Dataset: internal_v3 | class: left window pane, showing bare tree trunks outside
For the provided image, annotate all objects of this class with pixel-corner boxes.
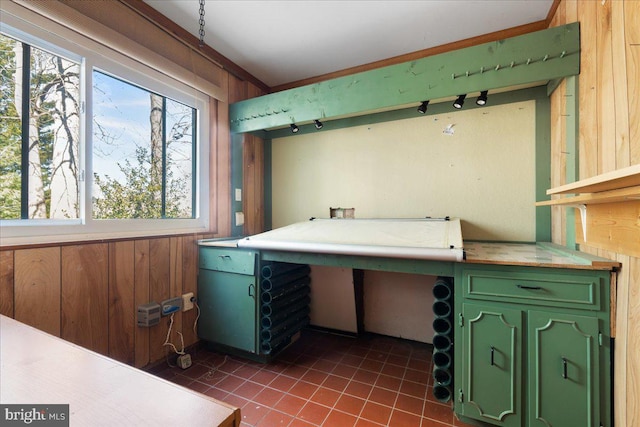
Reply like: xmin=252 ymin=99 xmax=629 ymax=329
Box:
xmin=0 ymin=36 xmax=80 ymax=219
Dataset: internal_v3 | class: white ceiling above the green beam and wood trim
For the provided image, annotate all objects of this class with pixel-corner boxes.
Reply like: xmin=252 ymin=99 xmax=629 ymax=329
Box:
xmin=144 ymin=0 xmax=553 ymax=87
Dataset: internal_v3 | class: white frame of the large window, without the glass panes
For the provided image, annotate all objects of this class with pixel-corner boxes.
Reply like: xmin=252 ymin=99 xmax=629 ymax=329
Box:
xmin=0 ymin=13 xmax=210 ymax=246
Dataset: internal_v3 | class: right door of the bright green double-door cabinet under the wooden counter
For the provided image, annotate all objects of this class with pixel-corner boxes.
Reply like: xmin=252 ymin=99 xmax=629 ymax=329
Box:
xmin=528 ymin=311 xmax=600 ymax=427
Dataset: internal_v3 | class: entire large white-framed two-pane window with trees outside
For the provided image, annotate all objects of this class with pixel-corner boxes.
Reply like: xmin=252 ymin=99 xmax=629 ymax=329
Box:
xmin=0 ymin=17 xmax=209 ymax=244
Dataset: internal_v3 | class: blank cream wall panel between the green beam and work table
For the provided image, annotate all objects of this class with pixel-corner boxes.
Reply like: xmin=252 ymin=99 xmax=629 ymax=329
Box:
xmin=272 ymin=100 xmax=536 ymax=241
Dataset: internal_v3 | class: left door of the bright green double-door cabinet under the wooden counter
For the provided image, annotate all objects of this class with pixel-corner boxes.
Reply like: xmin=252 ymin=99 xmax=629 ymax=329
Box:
xmin=460 ymin=304 xmax=523 ymax=427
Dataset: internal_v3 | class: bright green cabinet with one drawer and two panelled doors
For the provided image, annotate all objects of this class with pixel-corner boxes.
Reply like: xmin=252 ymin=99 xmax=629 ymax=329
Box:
xmin=454 ymin=265 xmax=611 ymax=427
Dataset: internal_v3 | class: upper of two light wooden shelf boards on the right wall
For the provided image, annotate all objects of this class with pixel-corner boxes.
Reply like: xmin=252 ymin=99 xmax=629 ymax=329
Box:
xmin=547 ymin=165 xmax=640 ymax=195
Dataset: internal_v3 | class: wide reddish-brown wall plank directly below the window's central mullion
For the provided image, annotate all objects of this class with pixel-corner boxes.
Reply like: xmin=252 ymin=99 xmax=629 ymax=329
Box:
xmin=60 ymin=243 xmax=109 ymax=354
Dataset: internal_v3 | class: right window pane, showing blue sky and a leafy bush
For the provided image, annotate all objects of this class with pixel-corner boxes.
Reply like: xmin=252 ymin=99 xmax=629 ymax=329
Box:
xmin=93 ymin=71 xmax=194 ymax=219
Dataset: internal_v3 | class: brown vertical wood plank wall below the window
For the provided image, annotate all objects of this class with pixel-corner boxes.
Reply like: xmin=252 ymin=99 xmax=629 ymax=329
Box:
xmin=0 ymin=234 xmax=214 ymax=367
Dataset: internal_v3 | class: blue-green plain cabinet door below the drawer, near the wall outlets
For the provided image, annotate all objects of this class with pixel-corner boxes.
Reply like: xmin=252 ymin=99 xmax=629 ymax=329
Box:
xmin=198 ymin=269 xmax=257 ymax=353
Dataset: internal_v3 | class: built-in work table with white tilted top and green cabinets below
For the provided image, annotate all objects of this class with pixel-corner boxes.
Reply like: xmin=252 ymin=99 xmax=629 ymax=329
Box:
xmin=198 ymin=226 xmax=620 ymax=427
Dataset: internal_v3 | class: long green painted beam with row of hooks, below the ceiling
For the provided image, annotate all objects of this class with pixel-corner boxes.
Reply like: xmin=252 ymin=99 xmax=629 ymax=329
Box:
xmin=229 ymin=23 xmax=580 ymax=133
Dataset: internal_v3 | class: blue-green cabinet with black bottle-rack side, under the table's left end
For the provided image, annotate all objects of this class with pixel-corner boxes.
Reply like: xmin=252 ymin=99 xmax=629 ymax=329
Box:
xmin=198 ymin=244 xmax=311 ymax=361
